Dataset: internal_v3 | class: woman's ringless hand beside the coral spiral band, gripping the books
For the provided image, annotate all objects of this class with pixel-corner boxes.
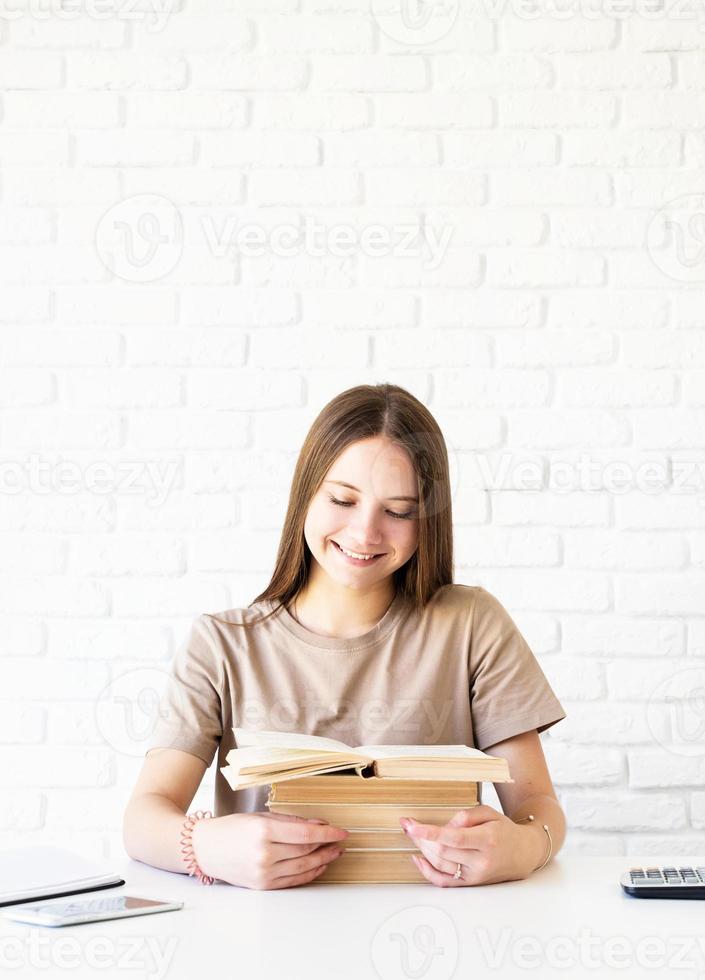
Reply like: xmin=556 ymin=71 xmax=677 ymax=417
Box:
xmin=191 ymin=813 xmax=348 ymax=889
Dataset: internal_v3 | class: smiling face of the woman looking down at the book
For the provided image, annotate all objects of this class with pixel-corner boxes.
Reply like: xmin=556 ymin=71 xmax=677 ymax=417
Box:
xmin=304 ymin=436 xmax=419 ymax=591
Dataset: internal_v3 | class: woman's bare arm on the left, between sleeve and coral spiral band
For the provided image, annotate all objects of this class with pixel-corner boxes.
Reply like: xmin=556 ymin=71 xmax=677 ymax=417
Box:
xmin=122 ymin=749 xmax=207 ymax=874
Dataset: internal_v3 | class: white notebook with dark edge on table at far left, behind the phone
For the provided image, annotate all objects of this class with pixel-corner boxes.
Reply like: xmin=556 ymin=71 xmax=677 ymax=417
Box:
xmin=0 ymin=844 xmax=125 ymax=905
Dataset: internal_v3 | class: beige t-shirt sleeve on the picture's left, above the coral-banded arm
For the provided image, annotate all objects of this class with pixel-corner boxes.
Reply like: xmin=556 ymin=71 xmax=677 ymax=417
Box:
xmin=147 ymin=616 xmax=224 ymax=766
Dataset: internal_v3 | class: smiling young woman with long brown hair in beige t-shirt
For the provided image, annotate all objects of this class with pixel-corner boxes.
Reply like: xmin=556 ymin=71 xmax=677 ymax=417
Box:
xmin=124 ymin=384 xmax=565 ymax=889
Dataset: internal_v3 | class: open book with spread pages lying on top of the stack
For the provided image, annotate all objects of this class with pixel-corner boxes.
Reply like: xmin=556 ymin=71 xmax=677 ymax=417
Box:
xmin=221 ymin=728 xmax=512 ymax=790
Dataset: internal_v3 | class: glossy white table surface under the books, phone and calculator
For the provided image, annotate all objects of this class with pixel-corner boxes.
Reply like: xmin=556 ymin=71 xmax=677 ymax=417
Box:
xmin=0 ymin=855 xmax=705 ymax=980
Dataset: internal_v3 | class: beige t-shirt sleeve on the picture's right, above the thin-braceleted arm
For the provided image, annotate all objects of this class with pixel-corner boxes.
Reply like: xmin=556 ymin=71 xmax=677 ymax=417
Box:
xmin=469 ymin=587 xmax=566 ymax=750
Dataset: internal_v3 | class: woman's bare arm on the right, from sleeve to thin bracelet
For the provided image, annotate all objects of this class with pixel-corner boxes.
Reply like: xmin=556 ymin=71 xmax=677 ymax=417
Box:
xmin=486 ymin=731 xmax=566 ymax=867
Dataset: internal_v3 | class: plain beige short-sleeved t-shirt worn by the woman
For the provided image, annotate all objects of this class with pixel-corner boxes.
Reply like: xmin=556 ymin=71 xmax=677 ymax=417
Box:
xmin=147 ymin=584 xmax=565 ymax=816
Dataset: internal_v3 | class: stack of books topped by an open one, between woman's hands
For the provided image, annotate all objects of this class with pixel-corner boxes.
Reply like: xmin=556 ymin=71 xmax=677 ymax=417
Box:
xmin=221 ymin=728 xmax=511 ymax=883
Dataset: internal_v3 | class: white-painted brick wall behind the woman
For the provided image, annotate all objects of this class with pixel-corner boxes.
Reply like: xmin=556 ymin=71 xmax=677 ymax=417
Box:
xmin=0 ymin=0 xmax=705 ymax=857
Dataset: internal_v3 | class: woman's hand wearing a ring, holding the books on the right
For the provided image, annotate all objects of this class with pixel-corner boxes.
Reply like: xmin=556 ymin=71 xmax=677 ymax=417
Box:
xmin=400 ymin=805 xmax=545 ymax=888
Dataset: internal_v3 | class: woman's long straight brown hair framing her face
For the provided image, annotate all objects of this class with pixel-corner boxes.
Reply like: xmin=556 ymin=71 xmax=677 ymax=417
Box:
xmin=206 ymin=384 xmax=453 ymax=626
